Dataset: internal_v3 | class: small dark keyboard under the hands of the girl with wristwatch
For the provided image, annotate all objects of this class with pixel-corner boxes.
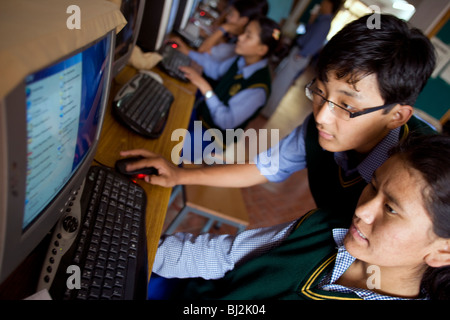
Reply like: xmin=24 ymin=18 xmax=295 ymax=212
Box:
xmin=159 ymin=43 xmax=192 ymax=82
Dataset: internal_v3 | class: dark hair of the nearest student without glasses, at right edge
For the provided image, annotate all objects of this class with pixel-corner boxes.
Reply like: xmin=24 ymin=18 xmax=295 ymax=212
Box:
xmin=391 ymin=135 xmax=450 ymax=300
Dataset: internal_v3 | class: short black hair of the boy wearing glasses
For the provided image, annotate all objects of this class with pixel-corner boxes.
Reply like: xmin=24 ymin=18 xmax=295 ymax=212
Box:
xmin=317 ymin=14 xmax=436 ymax=105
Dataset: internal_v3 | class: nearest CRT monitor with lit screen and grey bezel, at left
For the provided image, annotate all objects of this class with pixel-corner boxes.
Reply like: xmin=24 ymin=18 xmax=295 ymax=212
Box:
xmin=0 ymin=30 xmax=116 ymax=283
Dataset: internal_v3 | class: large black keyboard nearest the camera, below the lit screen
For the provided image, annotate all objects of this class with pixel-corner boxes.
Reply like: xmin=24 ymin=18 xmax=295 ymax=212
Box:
xmin=38 ymin=166 xmax=147 ymax=300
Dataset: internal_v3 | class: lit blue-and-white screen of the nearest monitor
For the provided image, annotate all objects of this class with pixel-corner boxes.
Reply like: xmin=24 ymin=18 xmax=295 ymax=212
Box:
xmin=22 ymin=38 xmax=107 ymax=229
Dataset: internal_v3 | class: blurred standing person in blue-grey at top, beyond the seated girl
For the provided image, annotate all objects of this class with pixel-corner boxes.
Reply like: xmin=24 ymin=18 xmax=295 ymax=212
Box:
xmin=262 ymin=0 xmax=342 ymax=118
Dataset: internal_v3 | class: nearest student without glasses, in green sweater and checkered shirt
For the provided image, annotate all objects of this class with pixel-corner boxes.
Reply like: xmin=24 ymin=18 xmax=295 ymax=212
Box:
xmin=149 ymin=135 xmax=450 ymax=300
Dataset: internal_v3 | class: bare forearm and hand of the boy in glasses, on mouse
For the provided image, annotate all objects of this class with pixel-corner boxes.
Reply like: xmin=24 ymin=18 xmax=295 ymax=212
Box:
xmin=120 ymin=149 xmax=268 ymax=188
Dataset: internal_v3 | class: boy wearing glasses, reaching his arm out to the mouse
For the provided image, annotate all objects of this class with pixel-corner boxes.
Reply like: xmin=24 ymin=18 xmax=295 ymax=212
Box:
xmin=121 ymin=15 xmax=435 ymax=215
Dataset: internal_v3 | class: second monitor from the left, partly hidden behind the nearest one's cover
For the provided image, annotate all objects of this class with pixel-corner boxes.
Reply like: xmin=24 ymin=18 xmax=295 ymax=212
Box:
xmin=112 ymin=0 xmax=145 ymax=77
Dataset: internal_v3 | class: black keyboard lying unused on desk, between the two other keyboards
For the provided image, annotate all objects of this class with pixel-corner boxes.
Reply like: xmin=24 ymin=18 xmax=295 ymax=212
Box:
xmin=113 ymin=73 xmax=174 ymax=139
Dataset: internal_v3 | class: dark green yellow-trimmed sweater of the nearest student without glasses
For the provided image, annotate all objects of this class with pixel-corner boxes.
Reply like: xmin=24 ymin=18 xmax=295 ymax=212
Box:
xmin=178 ymin=210 xmax=360 ymax=300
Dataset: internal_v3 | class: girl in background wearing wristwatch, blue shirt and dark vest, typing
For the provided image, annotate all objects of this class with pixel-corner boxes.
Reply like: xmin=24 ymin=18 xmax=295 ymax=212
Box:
xmin=174 ymin=16 xmax=280 ymax=160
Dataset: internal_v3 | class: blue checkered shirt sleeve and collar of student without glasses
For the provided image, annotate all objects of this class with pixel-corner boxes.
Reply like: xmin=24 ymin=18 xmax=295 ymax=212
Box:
xmin=153 ymin=221 xmax=428 ymax=300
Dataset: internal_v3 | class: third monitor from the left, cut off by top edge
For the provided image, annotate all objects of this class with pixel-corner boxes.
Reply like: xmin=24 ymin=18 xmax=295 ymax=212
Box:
xmin=137 ymin=0 xmax=180 ymax=52
